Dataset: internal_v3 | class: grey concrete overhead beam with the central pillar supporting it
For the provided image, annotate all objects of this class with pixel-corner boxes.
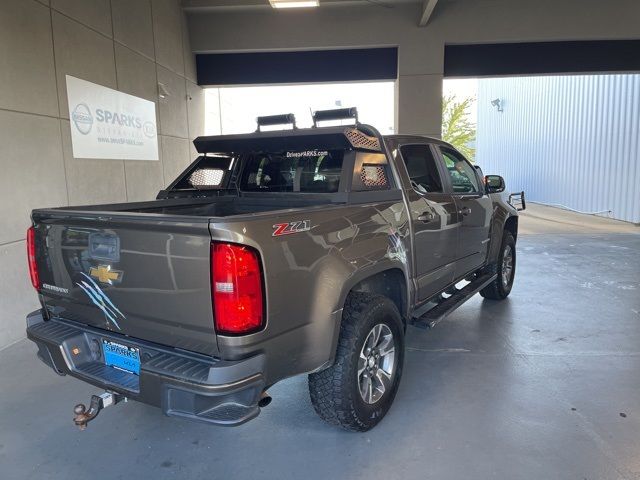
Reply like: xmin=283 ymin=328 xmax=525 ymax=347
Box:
xmin=189 ymin=0 xmax=640 ymax=136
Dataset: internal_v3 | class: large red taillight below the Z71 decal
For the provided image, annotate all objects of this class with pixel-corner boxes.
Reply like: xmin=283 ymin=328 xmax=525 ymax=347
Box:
xmin=211 ymin=242 xmax=264 ymax=335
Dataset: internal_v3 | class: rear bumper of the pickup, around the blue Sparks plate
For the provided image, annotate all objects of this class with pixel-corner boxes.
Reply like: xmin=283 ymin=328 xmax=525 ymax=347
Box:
xmin=27 ymin=311 xmax=265 ymax=426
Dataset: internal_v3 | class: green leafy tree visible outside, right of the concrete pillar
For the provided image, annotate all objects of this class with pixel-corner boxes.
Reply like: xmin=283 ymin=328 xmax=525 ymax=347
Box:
xmin=442 ymin=95 xmax=476 ymax=162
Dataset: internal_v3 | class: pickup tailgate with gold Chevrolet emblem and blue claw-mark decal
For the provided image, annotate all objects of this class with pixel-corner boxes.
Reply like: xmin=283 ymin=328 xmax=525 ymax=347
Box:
xmin=33 ymin=210 xmax=218 ymax=355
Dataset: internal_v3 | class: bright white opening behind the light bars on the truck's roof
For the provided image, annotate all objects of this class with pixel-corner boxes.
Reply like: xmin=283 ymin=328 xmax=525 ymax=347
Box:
xmin=205 ymin=81 xmax=395 ymax=135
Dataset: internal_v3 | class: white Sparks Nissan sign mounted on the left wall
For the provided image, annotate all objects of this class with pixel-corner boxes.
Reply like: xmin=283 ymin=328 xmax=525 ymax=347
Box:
xmin=67 ymin=75 xmax=158 ymax=160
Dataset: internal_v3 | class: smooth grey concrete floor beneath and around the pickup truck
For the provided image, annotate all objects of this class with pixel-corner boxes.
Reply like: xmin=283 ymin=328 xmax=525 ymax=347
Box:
xmin=0 ymin=215 xmax=640 ymax=480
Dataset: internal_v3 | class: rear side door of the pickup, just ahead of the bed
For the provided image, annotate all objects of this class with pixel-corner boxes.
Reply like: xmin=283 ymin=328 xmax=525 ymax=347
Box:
xmin=398 ymin=144 xmax=458 ymax=302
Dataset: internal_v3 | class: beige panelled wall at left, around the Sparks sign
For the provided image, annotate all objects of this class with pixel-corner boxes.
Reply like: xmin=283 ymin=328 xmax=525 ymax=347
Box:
xmin=0 ymin=0 xmax=204 ymax=348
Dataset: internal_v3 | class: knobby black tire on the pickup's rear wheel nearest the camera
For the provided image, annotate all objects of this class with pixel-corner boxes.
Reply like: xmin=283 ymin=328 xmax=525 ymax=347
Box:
xmin=309 ymin=292 xmax=404 ymax=432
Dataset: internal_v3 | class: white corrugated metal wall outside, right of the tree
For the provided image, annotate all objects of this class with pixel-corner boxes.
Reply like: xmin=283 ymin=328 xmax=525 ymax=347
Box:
xmin=476 ymin=74 xmax=640 ymax=223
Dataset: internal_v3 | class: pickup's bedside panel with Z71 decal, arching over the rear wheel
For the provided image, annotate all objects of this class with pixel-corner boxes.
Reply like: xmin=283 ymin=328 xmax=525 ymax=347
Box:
xmin=210 ymin=201 xmax=409 ymax=383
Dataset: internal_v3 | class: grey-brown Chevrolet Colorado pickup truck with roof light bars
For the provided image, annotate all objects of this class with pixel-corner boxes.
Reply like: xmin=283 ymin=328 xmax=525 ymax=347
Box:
xmin=27 ymin=109 xmax=518 ymax=431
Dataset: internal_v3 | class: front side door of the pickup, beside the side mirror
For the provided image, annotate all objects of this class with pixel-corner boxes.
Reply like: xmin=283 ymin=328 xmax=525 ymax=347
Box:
xmin=439 ymin=146 xmax=492 ymax=278
